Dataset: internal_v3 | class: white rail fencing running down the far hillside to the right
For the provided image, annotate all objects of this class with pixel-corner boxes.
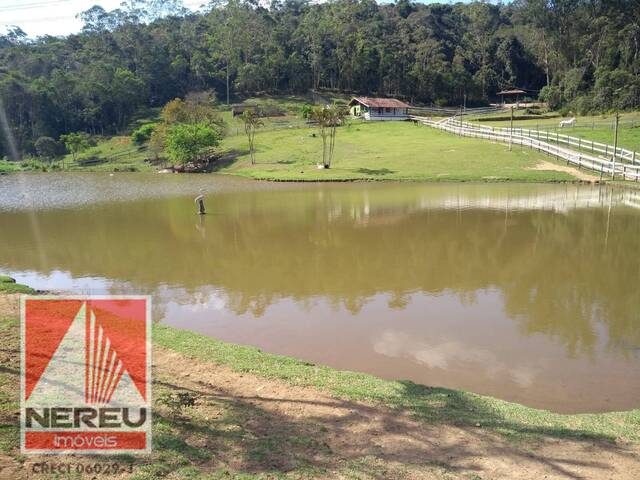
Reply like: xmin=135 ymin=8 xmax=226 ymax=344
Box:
xmin=411 ymin=116 xmax=640 ymax=181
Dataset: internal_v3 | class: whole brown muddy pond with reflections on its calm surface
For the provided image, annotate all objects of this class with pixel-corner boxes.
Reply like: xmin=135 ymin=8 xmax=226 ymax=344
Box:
xmin=0 ymin=174 xmax=640 ymax=412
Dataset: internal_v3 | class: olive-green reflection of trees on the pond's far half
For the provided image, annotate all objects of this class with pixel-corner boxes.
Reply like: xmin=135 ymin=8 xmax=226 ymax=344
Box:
xmin=0 ymin=184 xmax=640 ymax=410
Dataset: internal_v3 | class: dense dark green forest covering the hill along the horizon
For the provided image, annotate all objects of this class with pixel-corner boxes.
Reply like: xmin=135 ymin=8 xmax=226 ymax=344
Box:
xmin=0 ymin=0 xmax=640 ymax=158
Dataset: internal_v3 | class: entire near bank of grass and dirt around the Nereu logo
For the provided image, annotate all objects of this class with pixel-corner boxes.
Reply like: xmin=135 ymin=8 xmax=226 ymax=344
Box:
xmin=0 ymin=295 xmax=640 ymax=480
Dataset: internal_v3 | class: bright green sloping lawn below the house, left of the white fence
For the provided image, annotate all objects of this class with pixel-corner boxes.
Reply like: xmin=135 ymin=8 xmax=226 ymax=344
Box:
xmin=218 ymin=121 xmax=574 ymax=182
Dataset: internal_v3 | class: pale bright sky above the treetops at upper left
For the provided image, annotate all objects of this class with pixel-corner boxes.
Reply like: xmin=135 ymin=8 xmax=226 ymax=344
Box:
xmin=0 ymin=0 xmax=206 ymax=37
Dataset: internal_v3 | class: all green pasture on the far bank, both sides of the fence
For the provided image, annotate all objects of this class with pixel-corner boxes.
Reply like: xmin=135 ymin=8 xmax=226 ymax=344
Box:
xmin=6 ymin=99 xmax=640 ymax=182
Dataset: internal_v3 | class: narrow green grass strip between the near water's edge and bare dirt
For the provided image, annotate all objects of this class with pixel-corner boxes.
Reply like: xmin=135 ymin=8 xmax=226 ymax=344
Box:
xmin=154 ymin=325 xmax=640 ymax=441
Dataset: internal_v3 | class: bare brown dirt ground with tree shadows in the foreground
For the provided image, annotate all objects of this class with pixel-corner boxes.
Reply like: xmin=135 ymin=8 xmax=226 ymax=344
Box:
xmin=0 ymin=295 xmax=640 ymax=480
